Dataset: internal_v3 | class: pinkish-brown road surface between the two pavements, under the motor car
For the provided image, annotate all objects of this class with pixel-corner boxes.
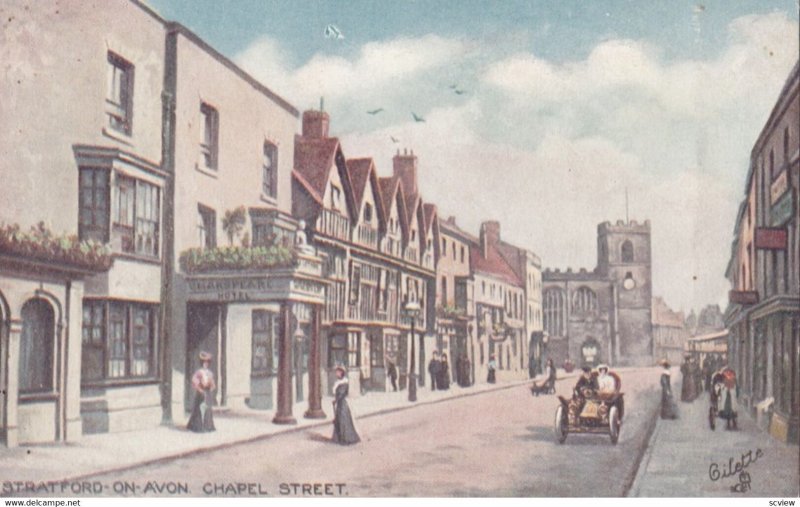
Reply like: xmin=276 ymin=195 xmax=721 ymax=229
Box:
xmin=88 ymin=369 xmax=659 ymax=497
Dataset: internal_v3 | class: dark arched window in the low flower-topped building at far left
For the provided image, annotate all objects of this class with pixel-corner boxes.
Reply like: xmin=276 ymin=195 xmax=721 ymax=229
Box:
xmin=19 ymin=299 xmax=55 ymax=394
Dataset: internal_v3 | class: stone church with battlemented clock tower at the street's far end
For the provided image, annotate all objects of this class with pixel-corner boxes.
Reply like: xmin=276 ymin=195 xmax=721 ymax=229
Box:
xmin=542 ymin=220 xmax=654 ymax=366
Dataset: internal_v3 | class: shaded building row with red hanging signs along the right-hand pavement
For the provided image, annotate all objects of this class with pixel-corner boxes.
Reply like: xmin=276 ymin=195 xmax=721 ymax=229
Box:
xmin=725 ymin=62 xmax=800 ymax=443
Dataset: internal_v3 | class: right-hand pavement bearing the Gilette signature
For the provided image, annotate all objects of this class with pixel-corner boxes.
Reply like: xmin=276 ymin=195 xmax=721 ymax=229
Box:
xmin=628 ymin=390 xmax=800 ymax=498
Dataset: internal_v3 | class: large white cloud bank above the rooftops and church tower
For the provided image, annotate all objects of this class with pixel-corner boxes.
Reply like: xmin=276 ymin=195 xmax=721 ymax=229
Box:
xmin=236 ymin=14 xmax=798 ymax=310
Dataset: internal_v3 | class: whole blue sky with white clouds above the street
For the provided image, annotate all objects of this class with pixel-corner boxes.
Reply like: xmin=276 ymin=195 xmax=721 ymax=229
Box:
xmin=148 ymin=0 xmax=800 ymax=312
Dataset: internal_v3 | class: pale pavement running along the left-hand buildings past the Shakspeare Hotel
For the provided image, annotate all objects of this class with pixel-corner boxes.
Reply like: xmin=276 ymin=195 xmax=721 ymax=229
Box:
xmin=0 ymin=372 xmax=570 ymax=482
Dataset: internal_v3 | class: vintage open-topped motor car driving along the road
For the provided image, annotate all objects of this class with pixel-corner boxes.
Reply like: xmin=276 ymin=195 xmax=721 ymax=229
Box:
xmin=554 ymin=372 xmax=625 ymax=444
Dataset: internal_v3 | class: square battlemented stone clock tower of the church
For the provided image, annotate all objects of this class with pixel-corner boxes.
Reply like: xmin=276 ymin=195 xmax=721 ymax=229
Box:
xmin=596 ymin=220 xmax=654 ymax=365
